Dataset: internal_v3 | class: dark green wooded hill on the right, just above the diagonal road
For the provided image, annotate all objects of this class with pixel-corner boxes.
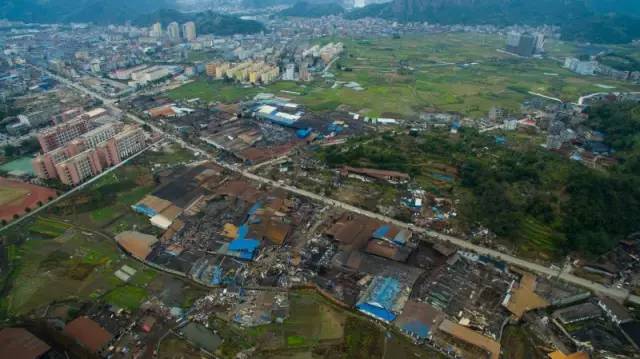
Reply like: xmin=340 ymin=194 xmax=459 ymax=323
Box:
xmin=318 ymin=102 xmax=640 ymax=258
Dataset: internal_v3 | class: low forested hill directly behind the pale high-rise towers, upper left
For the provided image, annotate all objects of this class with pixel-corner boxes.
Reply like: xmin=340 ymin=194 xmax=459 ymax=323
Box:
xmin=133 ymin=10 xmax=265 ymax=36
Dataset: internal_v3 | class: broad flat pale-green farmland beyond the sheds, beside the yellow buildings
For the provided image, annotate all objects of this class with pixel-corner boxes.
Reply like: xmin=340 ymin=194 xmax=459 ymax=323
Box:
xmin=169 ymin=33 xmax=640 ymax=117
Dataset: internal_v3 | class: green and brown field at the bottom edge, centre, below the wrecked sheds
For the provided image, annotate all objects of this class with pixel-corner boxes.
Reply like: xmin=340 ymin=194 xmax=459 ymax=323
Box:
xmin=211 ymin=290 xmax=442 ymax=359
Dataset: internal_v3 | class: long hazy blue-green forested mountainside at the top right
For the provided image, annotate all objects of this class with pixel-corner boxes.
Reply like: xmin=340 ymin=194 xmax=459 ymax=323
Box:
xmin=348 ymin=0 xmax=640 ymax=43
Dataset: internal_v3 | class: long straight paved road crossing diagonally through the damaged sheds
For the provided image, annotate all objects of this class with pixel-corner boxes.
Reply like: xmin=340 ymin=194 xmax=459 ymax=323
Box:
xmin=30 ymin=64 xmax=640 ymax=304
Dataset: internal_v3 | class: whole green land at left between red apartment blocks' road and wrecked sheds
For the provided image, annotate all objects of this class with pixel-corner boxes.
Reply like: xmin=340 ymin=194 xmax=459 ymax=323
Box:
xmin=0 ymin=146 xmax=199 ymax=317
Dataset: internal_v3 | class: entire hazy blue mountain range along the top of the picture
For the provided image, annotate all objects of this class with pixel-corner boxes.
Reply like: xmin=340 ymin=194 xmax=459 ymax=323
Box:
xmin=5 ymin=0 xmax=640 ymax=43
